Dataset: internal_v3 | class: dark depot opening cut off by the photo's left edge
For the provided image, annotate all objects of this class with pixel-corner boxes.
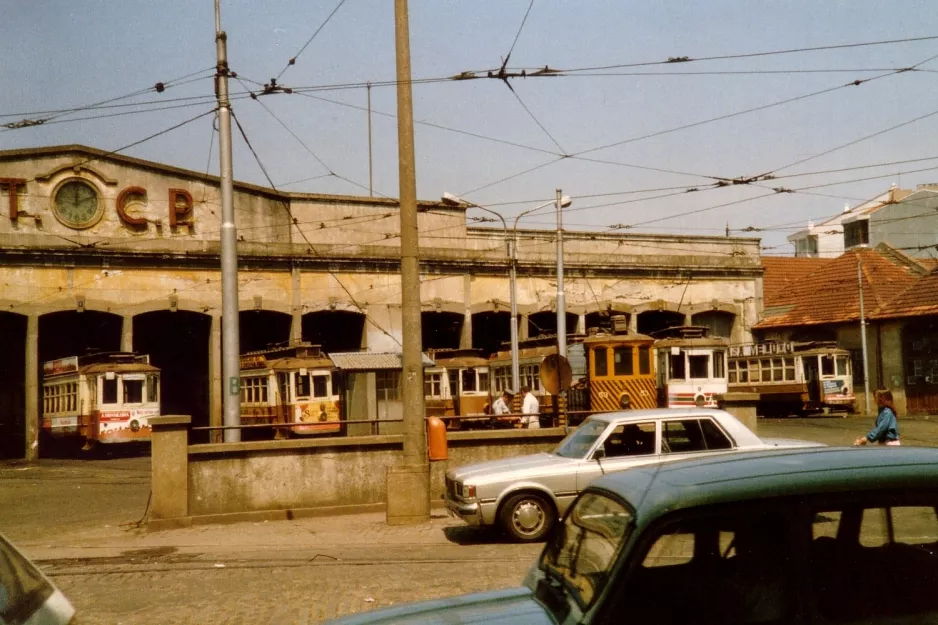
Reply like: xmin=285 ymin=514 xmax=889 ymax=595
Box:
xmin=0 ymin=312 xmax=26 ymax=459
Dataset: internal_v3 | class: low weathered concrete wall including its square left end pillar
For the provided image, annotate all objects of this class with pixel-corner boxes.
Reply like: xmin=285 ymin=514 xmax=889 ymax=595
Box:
xmin=150 ymin=421 xmax=565 ymax=529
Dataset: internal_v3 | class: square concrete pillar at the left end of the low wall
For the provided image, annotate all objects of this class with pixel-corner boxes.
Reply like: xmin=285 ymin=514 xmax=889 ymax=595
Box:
xmin=149 ymin=415 xmax=192 ymax=529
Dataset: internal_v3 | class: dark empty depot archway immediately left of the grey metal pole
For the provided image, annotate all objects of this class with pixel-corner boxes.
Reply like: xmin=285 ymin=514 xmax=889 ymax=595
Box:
xmin=134 ymin=310 xmax=210 ymax=442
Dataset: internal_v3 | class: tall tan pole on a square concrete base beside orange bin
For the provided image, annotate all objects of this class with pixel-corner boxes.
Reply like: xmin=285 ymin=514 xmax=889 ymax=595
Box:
xmin=387 ymin=0 xmax=430 ymax=525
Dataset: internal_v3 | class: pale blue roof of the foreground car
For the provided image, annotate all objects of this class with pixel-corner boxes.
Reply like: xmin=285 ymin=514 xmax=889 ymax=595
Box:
xmin=591 ymin=447 xmax=938 ymax=525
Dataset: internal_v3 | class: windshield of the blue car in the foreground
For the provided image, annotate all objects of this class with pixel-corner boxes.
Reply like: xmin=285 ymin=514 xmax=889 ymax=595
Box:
xmin=539 ymin=492 xmax=632 ymax=611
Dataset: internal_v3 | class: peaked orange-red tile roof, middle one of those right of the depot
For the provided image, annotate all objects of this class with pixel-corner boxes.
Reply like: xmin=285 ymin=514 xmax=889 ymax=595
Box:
xmin=755 ymin=249 xmax=921 ymax=329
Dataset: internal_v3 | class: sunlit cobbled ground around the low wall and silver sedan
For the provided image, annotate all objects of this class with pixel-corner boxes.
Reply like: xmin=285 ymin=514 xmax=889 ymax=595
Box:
xmin=0 ymin=417 xmax=938 ymax=625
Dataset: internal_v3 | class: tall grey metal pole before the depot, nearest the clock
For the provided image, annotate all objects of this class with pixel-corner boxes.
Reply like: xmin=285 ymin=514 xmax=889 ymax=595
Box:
xmin=215 ymin=0 xmax=241 ymax=443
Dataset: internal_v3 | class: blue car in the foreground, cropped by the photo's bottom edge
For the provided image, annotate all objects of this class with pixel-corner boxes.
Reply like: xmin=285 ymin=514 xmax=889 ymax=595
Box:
xmin=335 ymin=447 xmax=938 ymax=625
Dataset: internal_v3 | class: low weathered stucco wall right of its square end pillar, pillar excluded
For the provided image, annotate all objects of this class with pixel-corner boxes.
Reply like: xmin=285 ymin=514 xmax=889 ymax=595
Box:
xmin=187 ymin=429 xmax=564 ymax=516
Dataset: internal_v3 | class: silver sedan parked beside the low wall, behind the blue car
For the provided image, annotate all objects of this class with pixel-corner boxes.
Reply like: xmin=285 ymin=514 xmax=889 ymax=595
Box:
xmin=444 ymin=408 xmax=820 ymax=541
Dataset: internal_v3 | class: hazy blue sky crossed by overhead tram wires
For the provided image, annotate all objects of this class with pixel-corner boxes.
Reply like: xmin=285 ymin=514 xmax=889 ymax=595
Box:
xmin=0 ymin=0 xmax=938 ymax=253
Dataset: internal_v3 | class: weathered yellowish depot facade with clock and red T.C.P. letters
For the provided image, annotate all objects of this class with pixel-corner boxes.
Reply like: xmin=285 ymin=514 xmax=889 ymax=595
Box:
xmin=0 ymin=145 xmax=938 ymax=458
